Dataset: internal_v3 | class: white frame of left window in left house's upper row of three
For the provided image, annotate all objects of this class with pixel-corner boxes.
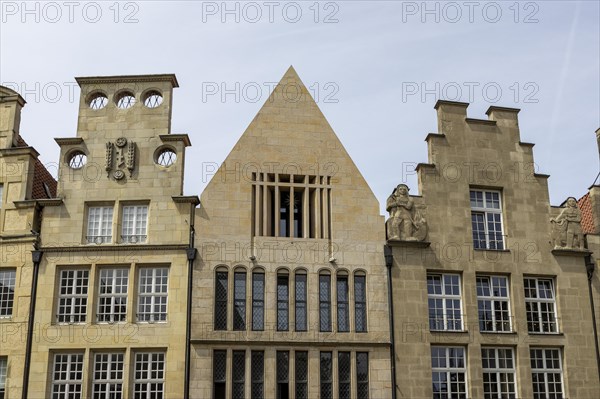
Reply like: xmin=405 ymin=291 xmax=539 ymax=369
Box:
xmin=56 ymin=269 xmax=90 ymax=324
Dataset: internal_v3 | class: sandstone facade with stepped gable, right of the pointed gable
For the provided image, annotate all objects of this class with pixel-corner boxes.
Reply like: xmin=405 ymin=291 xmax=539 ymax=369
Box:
xmin=389 ymin=101 xmax=600 ymax=399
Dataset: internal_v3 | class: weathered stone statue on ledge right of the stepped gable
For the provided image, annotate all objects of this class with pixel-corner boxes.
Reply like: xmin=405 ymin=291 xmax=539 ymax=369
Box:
xmin=550 ymin=197 xmax=584 ymax=249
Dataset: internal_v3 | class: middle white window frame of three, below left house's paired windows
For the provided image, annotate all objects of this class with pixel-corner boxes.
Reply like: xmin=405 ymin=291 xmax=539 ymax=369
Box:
xmin=96 ymin=267 xmax=129 ymax=323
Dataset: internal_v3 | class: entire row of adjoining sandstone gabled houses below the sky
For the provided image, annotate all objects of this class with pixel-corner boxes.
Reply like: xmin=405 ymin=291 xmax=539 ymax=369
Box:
xmin=0 ymin=68 xmax=600 ymax=399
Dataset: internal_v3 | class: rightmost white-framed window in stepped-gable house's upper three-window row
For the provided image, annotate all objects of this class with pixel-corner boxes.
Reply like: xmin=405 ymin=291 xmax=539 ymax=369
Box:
xmin=524 ymin=278 xmax=558 ymax=334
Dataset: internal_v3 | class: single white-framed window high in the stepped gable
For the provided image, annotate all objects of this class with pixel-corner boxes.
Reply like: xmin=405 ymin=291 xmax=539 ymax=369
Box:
xmin=470 ymin=190 xmax=504 ymax=250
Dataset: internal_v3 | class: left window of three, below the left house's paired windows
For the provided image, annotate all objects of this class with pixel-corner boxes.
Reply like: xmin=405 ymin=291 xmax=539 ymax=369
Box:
xmin=56 ymin=270 xmax=90 ymax=323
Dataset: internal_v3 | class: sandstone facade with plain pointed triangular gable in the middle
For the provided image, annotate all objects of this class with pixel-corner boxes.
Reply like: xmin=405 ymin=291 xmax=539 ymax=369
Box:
xmin=190 ymin=68 xmax=391 ymax=398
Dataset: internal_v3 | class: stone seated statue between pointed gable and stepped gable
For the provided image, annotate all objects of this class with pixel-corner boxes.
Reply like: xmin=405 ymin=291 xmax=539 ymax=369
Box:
xmin=385 ymin=184 xmax=427 ymax=241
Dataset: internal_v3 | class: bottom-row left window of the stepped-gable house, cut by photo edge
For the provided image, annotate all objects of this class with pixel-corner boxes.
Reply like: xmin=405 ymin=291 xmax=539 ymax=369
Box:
xmin=431 ymin=346 xmax=467 ymax=399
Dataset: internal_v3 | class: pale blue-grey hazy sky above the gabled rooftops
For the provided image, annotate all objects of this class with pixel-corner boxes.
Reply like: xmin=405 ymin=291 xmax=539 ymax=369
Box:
xmin=0 ymin=1 xmax=600 ymax=212
